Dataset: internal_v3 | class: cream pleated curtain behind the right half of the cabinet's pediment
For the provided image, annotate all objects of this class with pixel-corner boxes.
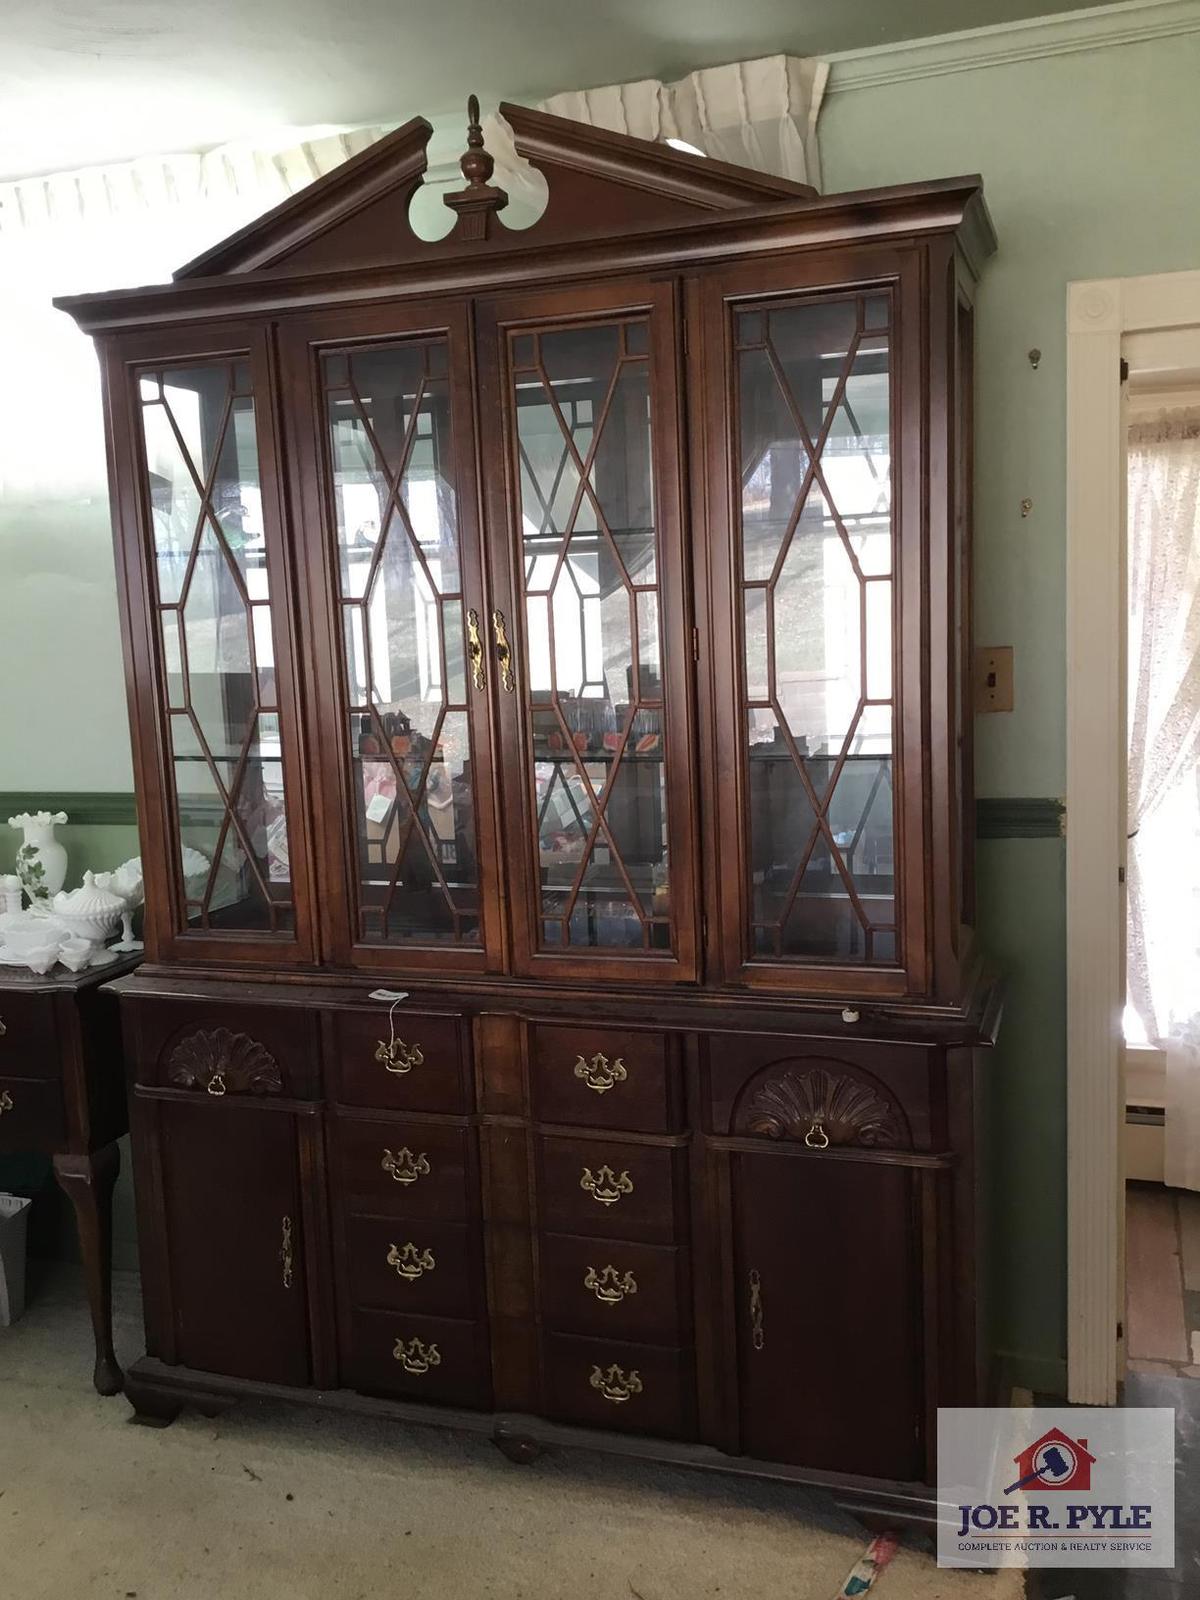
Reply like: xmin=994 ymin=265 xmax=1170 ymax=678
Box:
xmin=485 ymin=56 xmax=829 ymax=226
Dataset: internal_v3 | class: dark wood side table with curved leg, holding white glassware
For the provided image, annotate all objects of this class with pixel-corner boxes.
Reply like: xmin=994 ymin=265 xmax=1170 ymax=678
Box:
xmin=0 ymin=957 xmax=138 ymax=1395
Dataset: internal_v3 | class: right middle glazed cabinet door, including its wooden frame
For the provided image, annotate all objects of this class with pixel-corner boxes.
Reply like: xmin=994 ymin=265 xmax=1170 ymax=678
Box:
xmin=478 ymin=283 xmax=698 ymax=981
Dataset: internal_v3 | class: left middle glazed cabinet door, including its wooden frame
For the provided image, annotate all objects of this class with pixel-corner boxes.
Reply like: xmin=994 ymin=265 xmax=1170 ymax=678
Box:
xmin=282 ymin=306 xmax=502 ymax=971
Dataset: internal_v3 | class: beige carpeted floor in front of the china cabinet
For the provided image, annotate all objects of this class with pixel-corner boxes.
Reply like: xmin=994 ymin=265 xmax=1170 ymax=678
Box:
xmin=0 ymin=1274 xmax=1022 ymax=1600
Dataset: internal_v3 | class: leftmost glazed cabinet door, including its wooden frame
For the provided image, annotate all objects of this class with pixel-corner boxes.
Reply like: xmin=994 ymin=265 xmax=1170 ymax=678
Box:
xmin=106 ymin=325 xmax=314 ymax=966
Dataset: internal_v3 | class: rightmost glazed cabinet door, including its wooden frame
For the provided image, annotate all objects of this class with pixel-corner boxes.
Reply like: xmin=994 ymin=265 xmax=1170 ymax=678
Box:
xmin=693 ymin=251 xmax=939 ymax=995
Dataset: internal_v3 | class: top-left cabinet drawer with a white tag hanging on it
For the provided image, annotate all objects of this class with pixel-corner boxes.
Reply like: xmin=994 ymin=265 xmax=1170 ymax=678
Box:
xmin=333 ymin=1003 xmax=474 ymax=1115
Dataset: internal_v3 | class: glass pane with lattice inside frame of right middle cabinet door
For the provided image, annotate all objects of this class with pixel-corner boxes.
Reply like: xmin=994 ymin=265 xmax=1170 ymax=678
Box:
xmin=512 ymin=318 xmax=670 ymax=950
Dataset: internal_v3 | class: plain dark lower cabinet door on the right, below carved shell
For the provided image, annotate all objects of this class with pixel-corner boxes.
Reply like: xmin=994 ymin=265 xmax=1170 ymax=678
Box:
xmin=731 ymin=1155 xmax=922 ymax=1480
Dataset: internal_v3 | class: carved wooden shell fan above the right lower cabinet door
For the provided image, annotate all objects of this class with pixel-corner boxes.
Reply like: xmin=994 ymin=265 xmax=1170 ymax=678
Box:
xmin=734 ymin=1067 xmax=910 ymax=1149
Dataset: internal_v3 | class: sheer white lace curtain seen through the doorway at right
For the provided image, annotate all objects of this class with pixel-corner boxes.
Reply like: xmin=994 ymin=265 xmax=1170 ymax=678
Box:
xmin=1128 ymin=411 xmax=1200 ymax=1189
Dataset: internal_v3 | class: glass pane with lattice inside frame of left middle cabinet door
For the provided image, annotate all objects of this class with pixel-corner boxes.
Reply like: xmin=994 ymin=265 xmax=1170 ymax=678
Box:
xmin=323 ymin=341 xmax=480 ymax=944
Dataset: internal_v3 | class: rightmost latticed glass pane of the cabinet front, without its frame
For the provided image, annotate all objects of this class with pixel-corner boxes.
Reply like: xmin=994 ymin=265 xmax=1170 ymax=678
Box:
xmin=734 ymin=293 xmax=901 ymax=965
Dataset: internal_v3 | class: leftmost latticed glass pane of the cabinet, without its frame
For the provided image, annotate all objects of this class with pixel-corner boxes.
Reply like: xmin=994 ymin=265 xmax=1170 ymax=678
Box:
xmin=138 ymin=362 xmax=293 ymax=934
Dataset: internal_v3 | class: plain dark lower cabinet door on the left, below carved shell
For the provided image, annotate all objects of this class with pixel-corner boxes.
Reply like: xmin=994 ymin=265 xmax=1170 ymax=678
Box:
xmin=160 ymin=1102 xmax=310 ymax=1386
